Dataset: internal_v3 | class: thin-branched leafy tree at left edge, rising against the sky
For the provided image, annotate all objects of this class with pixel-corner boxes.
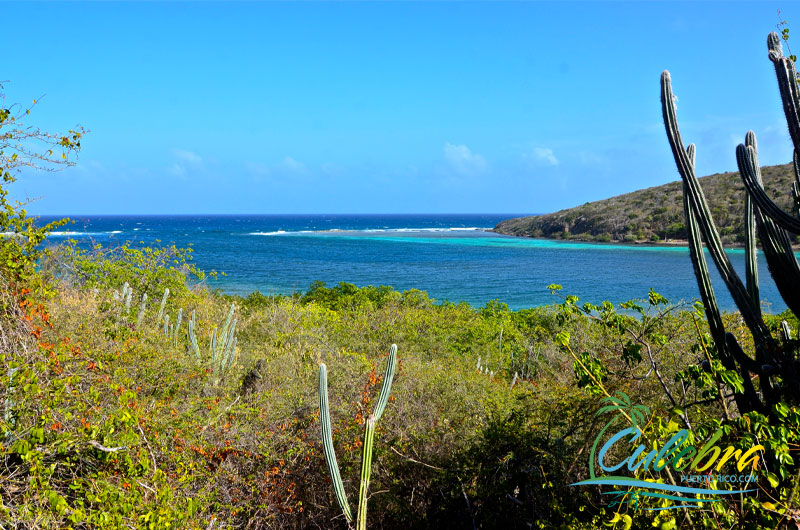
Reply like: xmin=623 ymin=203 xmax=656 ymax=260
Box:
xmin=0 ymin=83 xmax=86 ymax=288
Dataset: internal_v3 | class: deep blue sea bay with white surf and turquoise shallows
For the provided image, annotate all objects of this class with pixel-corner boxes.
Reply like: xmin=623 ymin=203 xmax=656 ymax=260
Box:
xmin=36 ymin=214 xmax=785 ymax=313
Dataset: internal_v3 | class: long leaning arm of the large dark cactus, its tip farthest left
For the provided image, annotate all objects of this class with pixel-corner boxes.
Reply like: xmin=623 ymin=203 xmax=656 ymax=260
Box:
xmin=661 ymin=70 xmax=772 ymax=344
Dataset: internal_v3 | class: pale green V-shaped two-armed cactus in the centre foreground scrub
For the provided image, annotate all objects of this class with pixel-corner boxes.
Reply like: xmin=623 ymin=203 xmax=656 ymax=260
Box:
xmin=319 ymin=344 xmax=397 ymax=530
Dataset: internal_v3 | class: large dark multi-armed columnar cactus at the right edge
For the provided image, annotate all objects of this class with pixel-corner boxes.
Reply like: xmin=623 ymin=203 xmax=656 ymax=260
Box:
xmin=661 ymin=32 xmax=800 ymax=414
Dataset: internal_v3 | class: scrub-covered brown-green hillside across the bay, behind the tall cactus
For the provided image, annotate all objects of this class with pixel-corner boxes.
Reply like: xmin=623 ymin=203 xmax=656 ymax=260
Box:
xmin=494 ymin=164 xmax=794 ymax=245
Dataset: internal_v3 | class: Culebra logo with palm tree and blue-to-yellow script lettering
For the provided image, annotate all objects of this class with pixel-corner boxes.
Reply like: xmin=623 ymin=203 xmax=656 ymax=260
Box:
xmin=572 ymin=392 xmax=764 ymax=510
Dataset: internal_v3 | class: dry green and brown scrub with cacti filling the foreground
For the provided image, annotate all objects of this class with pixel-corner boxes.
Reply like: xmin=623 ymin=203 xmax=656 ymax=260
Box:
xmin=0 ymin=27 xmax=800 ymax=530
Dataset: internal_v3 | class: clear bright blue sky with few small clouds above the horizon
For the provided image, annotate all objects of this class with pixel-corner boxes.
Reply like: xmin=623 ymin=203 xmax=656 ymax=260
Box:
xmin=6 ymin=1 xmax=800 ymax=214
